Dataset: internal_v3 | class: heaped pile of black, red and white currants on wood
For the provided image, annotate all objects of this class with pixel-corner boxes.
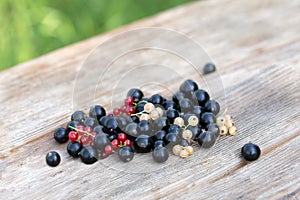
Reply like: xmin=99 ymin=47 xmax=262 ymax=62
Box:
xmin=47 ymin=80 xmax=236 ymax=166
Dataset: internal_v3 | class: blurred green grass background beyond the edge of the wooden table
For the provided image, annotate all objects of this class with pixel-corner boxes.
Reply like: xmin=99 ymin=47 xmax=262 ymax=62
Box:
xmin=0 ymin=0 xmax=192 ymax=70
